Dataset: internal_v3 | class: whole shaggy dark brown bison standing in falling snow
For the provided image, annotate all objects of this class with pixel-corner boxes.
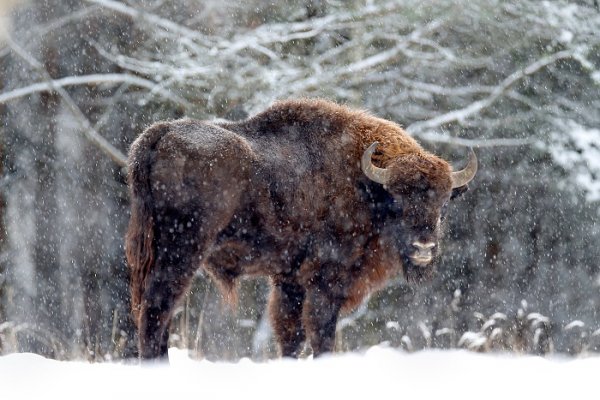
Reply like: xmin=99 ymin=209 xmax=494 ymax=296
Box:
xmin=126 ymin=100 xmax=477 ymax=359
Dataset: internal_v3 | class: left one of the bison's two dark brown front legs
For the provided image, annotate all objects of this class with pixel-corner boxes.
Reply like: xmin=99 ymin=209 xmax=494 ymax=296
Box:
xmin=269 ymin=279 xmax=305 ymax=358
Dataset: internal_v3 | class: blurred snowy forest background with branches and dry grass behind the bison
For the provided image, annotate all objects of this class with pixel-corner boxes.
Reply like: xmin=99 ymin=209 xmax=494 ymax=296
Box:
xmin=0 ymin=0 xmax=600 ymax=360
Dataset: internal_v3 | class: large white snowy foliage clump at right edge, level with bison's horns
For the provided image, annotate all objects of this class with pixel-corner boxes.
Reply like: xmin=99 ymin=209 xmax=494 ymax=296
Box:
xmin=549 ymin=121 xmax=600 ymax=202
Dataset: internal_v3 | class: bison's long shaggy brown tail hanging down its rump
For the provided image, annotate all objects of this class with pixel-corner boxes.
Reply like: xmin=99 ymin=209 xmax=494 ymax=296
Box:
xmin=125 ymin=123 xmax=169 ymax=326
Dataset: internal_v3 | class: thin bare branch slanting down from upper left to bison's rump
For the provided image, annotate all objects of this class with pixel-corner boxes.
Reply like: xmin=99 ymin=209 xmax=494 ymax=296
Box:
xmin=6 ymin=36 xmax=127 ymax=169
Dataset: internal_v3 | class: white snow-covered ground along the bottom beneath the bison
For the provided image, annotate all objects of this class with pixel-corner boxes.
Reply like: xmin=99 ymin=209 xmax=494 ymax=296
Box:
xmin=0 ymin=347 xmax=600 ymax=400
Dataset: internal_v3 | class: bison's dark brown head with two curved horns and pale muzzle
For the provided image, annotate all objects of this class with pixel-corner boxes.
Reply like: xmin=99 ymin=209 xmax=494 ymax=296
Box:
xmin=361 ymin=142 xmax=477 ymax=281
